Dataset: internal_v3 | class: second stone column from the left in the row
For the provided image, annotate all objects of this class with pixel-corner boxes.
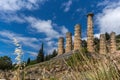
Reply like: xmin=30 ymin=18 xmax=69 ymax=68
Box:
xmin=65 ymin=32 xmax=72 ymax=53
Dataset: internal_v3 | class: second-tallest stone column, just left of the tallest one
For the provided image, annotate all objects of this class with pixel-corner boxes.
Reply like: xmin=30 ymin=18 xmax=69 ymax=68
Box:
xmin=74 ymin=24 xmax=82 ymax=50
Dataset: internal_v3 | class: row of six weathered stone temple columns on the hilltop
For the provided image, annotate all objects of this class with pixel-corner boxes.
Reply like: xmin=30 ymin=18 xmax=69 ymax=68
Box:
xmin=58 ymin=13 xmax=116 ymax=55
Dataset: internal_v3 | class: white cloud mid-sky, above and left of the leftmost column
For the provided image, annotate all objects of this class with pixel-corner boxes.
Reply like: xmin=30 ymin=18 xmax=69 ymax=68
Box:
xmin=24 ymin=16 xmax=68 ymax=39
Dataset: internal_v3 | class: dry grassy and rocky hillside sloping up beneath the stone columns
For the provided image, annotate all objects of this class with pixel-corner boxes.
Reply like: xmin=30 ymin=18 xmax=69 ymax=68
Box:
xmin=23 ymin=51 xmax=120 ymax=80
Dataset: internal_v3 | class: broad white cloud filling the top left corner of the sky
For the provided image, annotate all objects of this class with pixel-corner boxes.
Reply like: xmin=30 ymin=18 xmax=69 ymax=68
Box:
xmin=0 ymin=0 xmax=48 ymax=23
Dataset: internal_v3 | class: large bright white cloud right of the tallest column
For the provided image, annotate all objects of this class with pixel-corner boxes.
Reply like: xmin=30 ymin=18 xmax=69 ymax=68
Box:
xmin=95 ymin=1 xmax=120 ymax=34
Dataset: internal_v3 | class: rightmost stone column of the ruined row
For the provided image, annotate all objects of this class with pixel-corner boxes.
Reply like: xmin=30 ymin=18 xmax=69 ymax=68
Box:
xmin=110 ymin=32 xmax=117 ymax=53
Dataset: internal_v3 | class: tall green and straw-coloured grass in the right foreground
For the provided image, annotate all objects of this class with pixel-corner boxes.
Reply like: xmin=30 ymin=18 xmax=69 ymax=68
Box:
xmin=65 ymin=52 xmax=120 ymax=80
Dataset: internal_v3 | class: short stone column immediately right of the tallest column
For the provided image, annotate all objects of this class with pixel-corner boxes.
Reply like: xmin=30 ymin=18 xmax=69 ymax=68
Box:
xmin=99 ymin=34 xmax=107 ymax=54
